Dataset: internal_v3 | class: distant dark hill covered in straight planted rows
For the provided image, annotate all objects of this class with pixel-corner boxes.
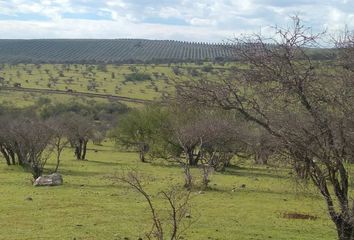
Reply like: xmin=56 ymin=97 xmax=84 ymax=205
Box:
xmin=0 ymin=39 xmax=238 ymax=63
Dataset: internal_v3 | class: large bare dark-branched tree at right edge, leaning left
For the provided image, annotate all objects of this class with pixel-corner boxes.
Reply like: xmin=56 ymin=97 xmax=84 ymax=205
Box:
xmin=177 ymin=16 xmax=354 ymax=240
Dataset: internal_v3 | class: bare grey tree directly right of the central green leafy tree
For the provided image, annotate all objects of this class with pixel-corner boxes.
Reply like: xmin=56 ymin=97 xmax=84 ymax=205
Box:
xmin=156 ymin=108 xmax=241 ymax=188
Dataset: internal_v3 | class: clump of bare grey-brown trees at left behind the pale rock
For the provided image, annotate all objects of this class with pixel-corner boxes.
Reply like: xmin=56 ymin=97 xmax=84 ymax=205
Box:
xmin=0 ymin=113 xmax=97 ymax=179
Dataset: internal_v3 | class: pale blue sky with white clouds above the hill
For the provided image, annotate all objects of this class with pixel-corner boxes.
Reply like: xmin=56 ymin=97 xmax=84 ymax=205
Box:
xmin=0 ymin=0 xmax=354 ymax=42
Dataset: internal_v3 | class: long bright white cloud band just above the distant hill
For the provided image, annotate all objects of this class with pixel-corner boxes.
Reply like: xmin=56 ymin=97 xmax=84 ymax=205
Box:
xmin=0 ymin=19 xmax=233 ymax=42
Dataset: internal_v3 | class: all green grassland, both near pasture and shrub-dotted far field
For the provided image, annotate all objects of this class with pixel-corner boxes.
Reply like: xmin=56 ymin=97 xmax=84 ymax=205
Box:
xmin=0 ymin=63 xmax=336 ymax=240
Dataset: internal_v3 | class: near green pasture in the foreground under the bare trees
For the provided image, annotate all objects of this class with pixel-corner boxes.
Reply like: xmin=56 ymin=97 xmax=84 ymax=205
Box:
xmin=0 ymin=142 xmax=335 ymax=240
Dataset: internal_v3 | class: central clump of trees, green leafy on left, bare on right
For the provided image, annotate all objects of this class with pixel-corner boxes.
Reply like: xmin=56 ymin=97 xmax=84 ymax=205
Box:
xmin=111 ymin=104 xmax=276 ymax=188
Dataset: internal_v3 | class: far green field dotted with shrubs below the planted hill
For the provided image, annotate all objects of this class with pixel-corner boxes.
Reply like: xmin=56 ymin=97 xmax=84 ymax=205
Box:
xmin=0 ymin=63 xmax=234 ymax=106
